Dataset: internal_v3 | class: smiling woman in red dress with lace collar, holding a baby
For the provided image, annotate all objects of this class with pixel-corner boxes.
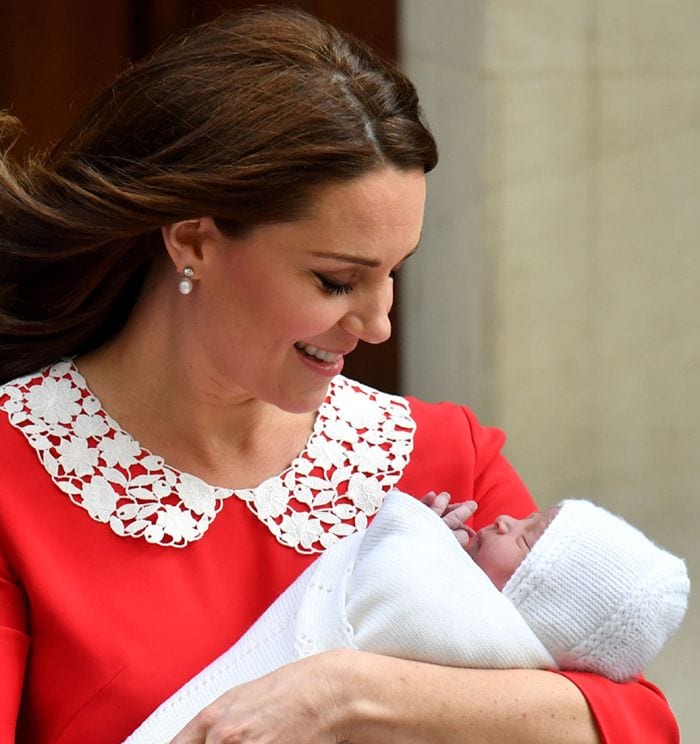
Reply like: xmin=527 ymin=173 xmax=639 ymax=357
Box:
xmin=0 ymin=10 xmax=677 ymax=744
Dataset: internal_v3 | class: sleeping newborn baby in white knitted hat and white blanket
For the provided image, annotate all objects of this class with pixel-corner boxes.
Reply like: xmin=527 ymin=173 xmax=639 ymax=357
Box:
xmin=127 ymin=491 xmax=689 ymax=744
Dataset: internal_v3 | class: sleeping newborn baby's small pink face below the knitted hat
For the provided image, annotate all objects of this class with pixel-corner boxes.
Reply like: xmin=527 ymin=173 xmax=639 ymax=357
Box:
xmin=466 ymin=507 xmax=557 ymax=590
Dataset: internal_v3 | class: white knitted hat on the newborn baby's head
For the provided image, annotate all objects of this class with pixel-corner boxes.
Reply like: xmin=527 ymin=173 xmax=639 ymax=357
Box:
xmin=503 ymin=499 xmax=690 ymax=681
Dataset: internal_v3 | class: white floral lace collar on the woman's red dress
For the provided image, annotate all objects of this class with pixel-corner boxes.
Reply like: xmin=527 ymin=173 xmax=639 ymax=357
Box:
xmin=0 ymin=361 xmax=415 ymax=553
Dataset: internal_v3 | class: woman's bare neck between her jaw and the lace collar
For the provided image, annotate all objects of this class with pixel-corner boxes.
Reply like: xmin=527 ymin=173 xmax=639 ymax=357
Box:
xmin=76 ymin=290 xmax=315 ymax=488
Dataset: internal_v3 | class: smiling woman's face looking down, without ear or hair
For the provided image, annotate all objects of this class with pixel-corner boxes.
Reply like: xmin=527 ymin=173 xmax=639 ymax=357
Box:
xmin=183 ymin=168 xmax=425 ymax=412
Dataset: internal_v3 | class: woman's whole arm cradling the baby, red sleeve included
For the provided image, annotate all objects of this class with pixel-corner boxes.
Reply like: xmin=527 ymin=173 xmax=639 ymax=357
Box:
xmin=174 ymin=407 xmax=678 ymax=744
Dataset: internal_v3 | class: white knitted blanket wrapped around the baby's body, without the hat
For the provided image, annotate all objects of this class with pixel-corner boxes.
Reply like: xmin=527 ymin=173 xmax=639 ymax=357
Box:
xmin=126 ymin=491 xmax=556 ymax=744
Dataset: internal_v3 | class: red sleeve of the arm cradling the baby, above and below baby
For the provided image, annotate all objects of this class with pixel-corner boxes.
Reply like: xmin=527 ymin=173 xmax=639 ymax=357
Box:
xmin=398 ymin=399 xmax=680 ymax=744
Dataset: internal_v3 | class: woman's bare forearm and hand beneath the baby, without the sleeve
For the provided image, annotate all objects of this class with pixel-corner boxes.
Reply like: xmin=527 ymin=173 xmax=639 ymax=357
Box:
xmin=173 ymin=650 xmax=599 ymax=744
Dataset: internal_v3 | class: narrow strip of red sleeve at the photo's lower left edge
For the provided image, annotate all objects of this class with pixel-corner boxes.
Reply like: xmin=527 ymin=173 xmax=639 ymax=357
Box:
xmin=0 ymin=557 xmax=29 ymax=744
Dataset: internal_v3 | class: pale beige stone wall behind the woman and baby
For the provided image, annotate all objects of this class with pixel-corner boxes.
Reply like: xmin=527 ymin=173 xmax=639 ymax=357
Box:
xmin=400 ymin=0 xmax=700 ymax=741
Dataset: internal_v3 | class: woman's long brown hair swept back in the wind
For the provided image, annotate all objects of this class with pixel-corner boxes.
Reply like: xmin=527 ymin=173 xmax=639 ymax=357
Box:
xmin=0 ymin=8 xmax=437 ymax=382
